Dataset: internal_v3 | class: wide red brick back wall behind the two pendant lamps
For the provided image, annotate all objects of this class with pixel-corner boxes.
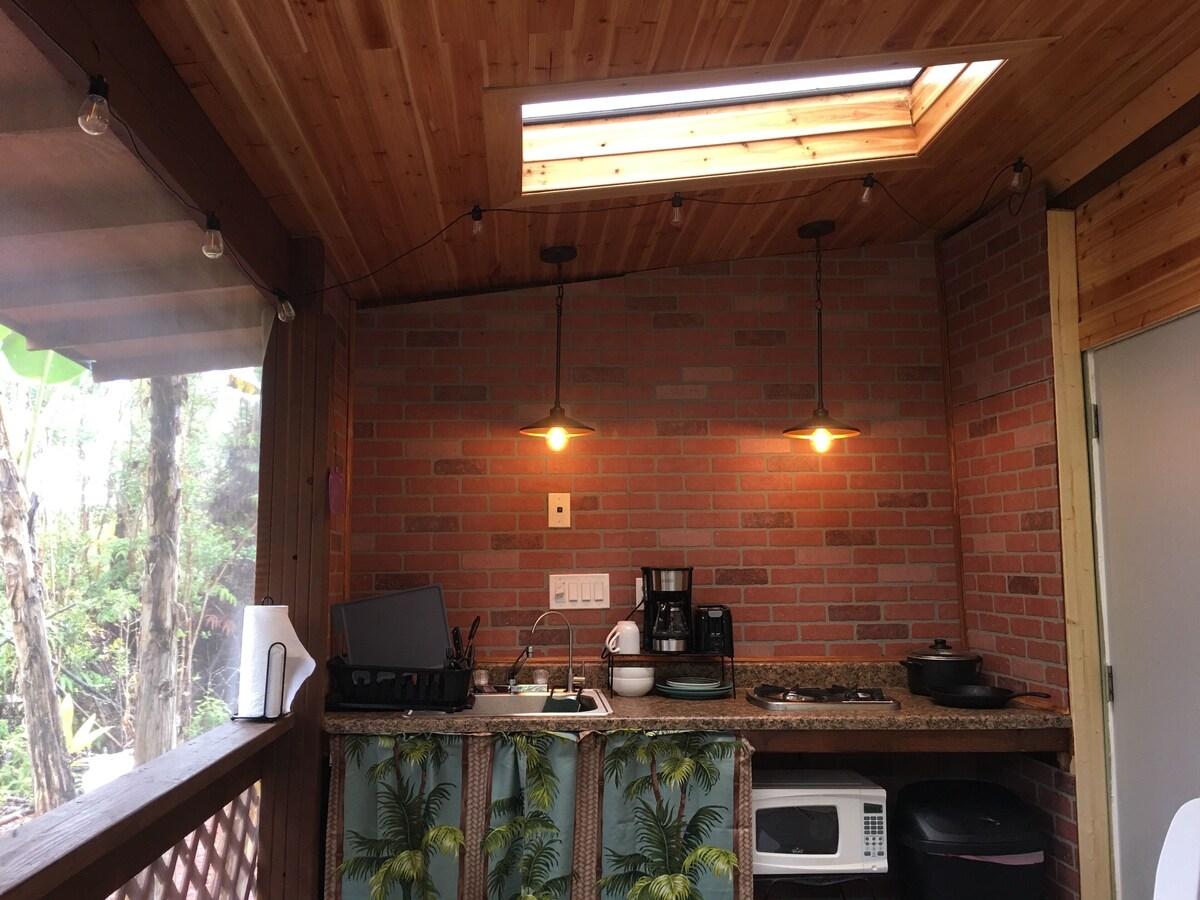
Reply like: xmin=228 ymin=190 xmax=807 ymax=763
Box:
xmin=350 ymin=244 xmax=959 ymax=659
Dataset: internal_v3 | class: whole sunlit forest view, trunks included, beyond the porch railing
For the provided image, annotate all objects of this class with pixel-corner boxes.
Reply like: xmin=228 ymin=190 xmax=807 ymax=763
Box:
xmin=0 ymin=335 xmax=260 ymax=828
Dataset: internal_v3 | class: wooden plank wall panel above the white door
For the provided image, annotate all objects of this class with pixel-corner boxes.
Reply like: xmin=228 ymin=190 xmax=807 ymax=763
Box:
xmin=1075 ymin=130 xmax=1200 ymax=349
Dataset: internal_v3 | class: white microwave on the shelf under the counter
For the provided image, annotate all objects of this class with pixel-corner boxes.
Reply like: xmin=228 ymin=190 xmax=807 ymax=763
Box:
xmin=754 ymin=769 xmax=888 ymax=875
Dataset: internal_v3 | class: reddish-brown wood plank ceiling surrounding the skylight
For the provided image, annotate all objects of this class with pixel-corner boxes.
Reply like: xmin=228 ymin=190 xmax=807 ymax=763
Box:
xmin=11 ymin=0 xmax=1200 ymax=336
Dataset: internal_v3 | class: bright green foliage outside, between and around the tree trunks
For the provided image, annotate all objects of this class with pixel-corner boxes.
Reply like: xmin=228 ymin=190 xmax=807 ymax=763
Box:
xmin=0 ymin=367 xmax=259 ymax=797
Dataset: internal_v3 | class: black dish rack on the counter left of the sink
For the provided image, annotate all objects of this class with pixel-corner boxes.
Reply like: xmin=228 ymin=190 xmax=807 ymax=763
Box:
xmin=325 ymin=656 xmax=472 ymax=713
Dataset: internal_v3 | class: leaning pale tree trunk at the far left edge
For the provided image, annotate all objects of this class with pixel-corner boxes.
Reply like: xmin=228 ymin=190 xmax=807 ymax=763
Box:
xmin=0 ymin=400 xmax=74 ymax=814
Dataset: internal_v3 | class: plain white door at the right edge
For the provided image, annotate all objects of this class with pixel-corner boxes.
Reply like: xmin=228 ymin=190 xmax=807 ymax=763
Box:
xmin=1091 ymin=314 xmax=1200 ymax=900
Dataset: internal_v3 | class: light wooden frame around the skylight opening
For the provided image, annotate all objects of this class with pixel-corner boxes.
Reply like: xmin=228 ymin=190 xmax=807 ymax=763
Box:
xmin=484 ymin=37 xmax=1055 ymax=205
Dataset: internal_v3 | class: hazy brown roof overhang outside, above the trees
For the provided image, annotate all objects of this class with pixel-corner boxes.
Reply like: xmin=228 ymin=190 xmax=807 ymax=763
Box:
xmin=0 ymin=2 xmax=271 ymax=380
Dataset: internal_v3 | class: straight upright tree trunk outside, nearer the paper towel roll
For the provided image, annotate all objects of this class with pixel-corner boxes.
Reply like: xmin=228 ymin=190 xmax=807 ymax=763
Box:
xmin=133 ymin=376 xmax=187 ymax=764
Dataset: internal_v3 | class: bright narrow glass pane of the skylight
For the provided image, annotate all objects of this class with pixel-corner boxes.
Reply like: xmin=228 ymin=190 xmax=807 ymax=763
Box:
xmin=521 ymin=66 xmax=922 ymax=124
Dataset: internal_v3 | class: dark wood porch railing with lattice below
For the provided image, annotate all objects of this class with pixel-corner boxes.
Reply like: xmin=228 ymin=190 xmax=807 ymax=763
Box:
xmin=0 ymin=718 xmax=293 ymax=900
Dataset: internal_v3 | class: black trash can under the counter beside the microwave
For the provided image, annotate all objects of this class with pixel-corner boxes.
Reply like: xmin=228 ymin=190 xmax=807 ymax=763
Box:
xmin=892 ymin=780 xmax=1046 ymax=900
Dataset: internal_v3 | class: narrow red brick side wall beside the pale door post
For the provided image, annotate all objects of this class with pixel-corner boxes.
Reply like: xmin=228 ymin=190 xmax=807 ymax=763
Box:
xmin=943 ymin=188 xmax=1067 ymax=704
